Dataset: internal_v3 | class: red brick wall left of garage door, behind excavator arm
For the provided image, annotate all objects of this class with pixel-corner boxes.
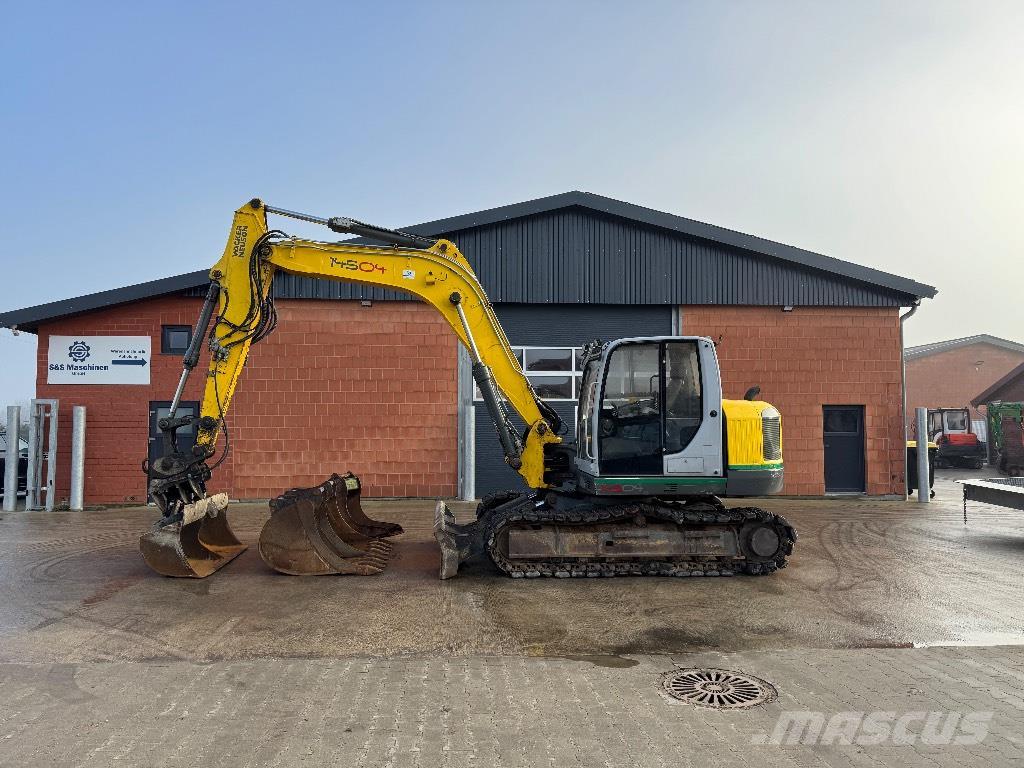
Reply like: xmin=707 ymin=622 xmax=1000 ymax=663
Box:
xmin=36 ymin=297 xmax=458 ymax=504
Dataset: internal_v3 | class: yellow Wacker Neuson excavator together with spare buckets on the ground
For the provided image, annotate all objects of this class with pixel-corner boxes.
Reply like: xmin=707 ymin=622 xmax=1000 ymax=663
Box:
xmin=141 ymin=200 xmax=797 ymax=579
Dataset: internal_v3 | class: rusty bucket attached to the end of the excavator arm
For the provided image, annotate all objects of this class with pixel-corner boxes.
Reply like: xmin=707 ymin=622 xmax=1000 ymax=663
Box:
xmin=139 ymin=494 xmax=246 ymax=579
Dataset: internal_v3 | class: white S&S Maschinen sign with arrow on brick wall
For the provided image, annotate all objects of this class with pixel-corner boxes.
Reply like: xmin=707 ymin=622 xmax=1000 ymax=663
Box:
xmin=46 ymin=336 xmax=152 ymax=384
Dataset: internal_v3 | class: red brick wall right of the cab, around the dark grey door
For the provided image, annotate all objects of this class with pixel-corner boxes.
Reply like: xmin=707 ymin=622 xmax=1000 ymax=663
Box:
xmin=681 ymin=306 xmax=905 ymax=495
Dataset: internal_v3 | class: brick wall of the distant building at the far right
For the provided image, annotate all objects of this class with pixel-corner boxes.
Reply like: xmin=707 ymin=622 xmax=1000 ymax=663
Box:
xmin=906 ymin=344 xmax=1024 ymax=426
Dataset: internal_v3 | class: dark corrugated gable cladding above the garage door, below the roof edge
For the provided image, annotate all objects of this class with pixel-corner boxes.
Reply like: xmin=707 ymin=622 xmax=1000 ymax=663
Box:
xmin=445 ymin=207 xmax=918 ymax=306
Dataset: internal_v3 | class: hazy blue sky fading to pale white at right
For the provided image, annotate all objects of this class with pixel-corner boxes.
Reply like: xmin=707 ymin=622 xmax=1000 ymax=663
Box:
xmin=0 ymin=0 xmax=1024 ymax=404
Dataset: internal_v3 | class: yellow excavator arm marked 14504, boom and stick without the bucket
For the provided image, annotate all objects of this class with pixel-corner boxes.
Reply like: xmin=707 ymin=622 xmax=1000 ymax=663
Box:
xmin=150 ymin=200 xmax=561 ymax=540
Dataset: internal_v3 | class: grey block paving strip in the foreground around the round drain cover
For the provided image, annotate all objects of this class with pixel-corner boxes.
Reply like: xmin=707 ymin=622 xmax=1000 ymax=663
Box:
xmin=0 ymin=647 xmax=1024 ymax=768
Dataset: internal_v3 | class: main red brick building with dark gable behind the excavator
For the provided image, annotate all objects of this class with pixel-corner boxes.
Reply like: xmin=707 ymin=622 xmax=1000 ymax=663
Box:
xmin=0 ymin=193 xmax=937 ymax=503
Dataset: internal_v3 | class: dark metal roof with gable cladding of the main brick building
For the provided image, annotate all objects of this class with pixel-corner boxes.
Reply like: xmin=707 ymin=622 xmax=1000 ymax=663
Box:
xmin=0 ymin=191 xmax=936 ymax=332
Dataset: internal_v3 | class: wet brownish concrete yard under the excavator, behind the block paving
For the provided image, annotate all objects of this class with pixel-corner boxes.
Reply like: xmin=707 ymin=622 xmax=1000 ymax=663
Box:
xmin=0 ymin=473 xmax=1024 ymax=663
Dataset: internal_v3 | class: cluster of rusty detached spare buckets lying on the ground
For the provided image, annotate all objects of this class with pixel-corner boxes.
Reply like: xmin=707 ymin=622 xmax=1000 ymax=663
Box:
xmin=259 ymin=473 xmax=402 ymax=575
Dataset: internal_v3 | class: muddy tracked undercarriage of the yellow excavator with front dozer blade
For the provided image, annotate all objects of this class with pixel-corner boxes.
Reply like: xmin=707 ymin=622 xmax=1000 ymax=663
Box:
xmin=434 ymin=493 xmax=797 ymax=579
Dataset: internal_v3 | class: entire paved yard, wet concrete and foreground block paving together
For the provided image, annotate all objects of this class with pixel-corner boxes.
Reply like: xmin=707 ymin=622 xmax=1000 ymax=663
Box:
xmin=0 ymin=468 xmax=1024 ymax=766
